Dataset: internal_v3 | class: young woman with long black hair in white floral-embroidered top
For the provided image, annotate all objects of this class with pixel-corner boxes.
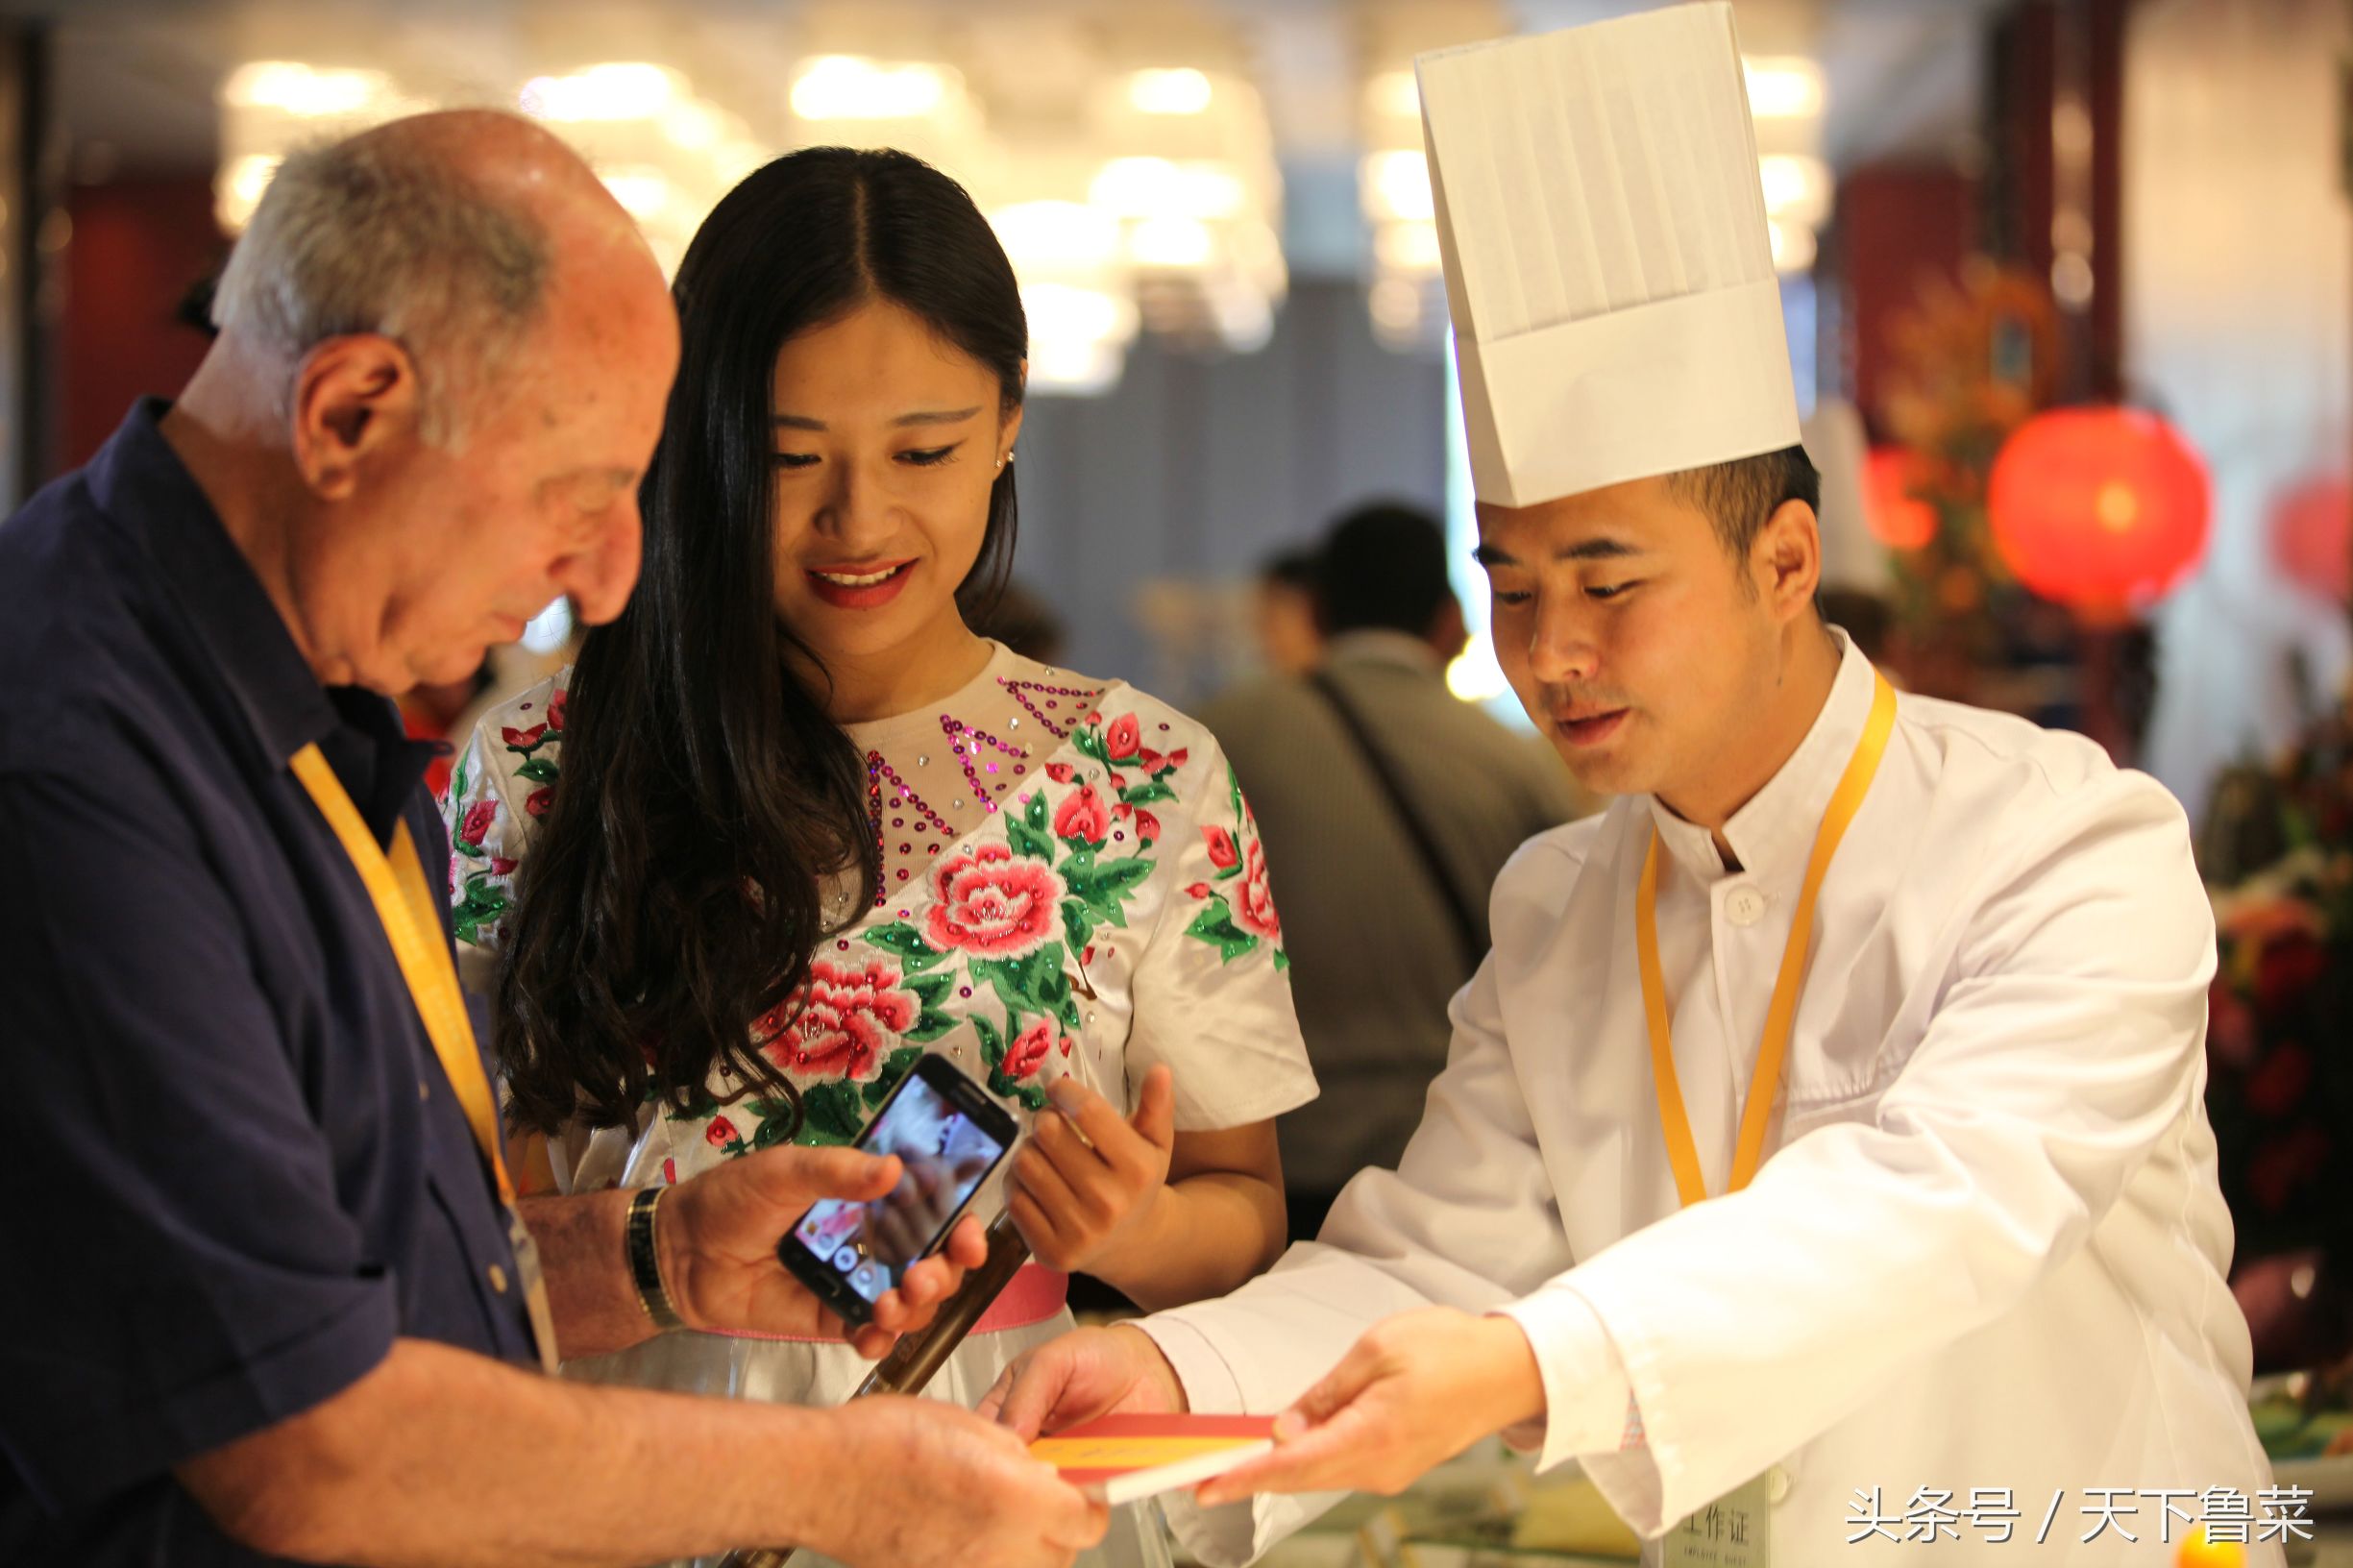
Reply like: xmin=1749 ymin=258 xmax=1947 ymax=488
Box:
xmin=450 ymin=148 xmax=1315 ymax=1561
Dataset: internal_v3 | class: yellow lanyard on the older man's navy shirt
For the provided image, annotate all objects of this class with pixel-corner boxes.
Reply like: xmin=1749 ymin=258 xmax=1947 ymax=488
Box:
xmin=294 ymin=742 xmax=515 ymax=1208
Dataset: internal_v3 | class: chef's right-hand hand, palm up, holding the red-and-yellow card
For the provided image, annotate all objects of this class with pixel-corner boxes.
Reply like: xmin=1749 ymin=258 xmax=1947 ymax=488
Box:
xmin=1198 ymin=1307 xmax=1544 ymax=1507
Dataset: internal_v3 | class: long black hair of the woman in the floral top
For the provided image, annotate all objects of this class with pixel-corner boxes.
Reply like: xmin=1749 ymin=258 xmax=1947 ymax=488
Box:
xmin=494 ymin=146 xmax=1028 ymax=1133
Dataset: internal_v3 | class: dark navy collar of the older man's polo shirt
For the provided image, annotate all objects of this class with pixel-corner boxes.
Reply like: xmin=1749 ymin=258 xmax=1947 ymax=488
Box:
xmin=89 ymin=398 xmax=341 ymax=765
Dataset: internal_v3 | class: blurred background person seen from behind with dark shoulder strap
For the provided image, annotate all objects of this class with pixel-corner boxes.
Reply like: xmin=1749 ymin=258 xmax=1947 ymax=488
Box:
xmin=1202 ymin=502 xmax=1579 ymax=1238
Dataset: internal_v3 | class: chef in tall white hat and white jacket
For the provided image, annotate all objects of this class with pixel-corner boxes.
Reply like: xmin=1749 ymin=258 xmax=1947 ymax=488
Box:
xmin=984 ymin=5 xmax=2301 ymax=1568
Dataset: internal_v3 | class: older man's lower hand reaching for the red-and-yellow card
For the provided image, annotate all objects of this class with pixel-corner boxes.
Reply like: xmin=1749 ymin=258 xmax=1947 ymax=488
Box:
xmin=809 ymin=1396 xmax=1108 ymax=1568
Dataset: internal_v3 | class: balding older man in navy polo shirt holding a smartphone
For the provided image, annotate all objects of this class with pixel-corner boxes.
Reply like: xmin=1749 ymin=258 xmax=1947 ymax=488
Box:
xmin=0 ymin=113 xmax=1101 ymax=1566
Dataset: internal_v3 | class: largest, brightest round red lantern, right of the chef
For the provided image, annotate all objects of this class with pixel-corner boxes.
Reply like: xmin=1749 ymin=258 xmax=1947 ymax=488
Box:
xmin=1986 ymin=407 xmax=2210 ymax=619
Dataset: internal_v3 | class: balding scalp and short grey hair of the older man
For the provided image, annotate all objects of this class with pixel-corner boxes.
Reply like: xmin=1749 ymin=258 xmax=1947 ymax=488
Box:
xmin=214 ymin=110 xmax=661 ymax=440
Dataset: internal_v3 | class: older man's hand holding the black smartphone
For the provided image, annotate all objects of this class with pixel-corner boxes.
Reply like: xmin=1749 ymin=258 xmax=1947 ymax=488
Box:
xmin=656 ymin=1146 xmax=989 ymax=1359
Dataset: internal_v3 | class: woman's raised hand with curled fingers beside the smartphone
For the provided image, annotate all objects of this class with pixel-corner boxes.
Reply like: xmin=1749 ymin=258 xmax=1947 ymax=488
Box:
xmin=1005 ymin=1066 xmax=1177 ymax=1286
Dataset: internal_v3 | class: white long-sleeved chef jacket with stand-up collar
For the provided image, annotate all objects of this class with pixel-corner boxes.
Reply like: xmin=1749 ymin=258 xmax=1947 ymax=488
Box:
xmin=1143 ymin=645 xmax=2280 ymax=1568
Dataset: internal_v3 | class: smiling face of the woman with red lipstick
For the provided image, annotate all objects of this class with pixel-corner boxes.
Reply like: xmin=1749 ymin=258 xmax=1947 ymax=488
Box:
xmin=772 ymin=299 xmax=1021 ymax=664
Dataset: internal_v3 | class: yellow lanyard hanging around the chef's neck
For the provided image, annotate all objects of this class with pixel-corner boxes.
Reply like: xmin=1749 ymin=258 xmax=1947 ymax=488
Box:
xmin=1633 ymin=671 xmax=1897 ymax=1208
